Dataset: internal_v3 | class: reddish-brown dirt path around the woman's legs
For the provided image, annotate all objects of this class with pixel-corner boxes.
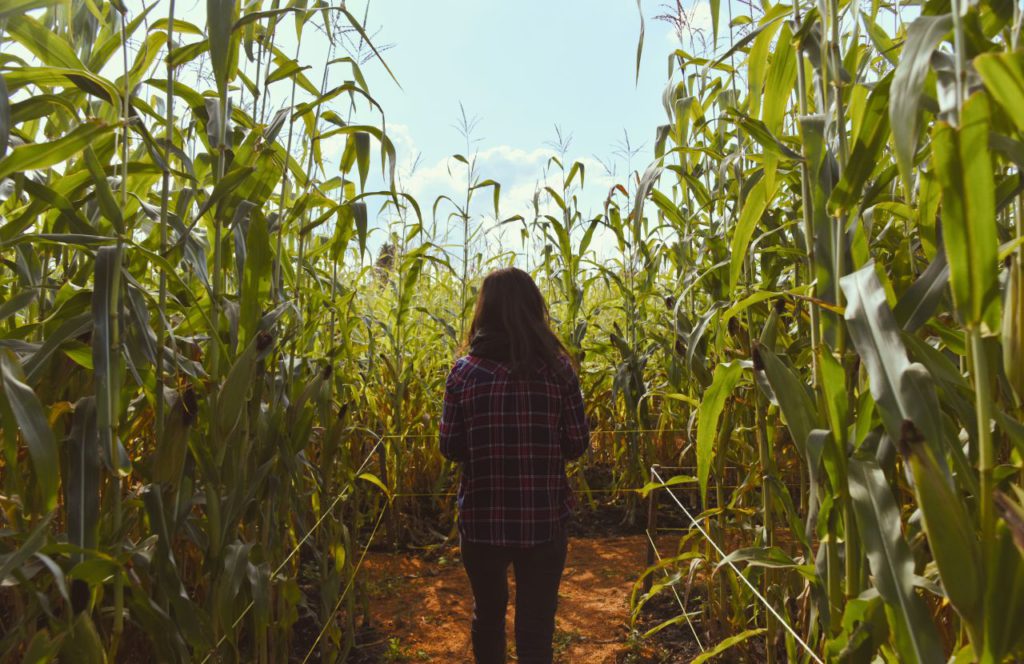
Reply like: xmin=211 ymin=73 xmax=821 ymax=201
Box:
xmin=366 ymin=535 xmax=663 ymax=664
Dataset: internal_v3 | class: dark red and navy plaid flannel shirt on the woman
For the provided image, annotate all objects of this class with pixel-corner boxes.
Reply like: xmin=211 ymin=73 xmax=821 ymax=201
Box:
xmin=440 ymin=356 xmax=590 ymax=547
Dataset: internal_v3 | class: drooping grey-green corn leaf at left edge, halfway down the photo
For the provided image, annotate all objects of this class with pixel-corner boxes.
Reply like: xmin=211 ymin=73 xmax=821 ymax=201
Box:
xmin=0 ymin=350 xmax=59 ymax=514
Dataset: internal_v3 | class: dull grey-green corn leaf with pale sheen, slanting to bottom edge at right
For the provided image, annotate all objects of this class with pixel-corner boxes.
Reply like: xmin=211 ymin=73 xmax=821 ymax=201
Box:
xmin=849 ymin=459 xmax=945 ymax=664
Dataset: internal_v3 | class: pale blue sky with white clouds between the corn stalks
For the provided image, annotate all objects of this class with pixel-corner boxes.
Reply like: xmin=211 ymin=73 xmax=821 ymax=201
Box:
xmin=329 ymin=0 xmax=707 ymax=240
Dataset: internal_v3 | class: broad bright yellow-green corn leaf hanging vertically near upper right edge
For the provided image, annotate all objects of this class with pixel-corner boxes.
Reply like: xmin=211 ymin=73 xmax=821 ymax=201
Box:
xmin=932 ymin=93 xmax=999 ymax=332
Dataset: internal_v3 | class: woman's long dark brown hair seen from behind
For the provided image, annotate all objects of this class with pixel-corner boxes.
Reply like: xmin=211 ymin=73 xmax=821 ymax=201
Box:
xmin=469 ymin=267 xmax=568 ymax=375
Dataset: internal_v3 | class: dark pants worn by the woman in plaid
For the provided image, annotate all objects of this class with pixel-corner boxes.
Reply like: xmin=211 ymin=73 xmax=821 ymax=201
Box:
xmin=462 ymin=533 xmax=567 ymax=664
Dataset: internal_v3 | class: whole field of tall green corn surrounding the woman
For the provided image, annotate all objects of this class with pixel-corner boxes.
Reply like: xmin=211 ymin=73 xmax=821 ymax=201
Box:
xmin=0 ymin=0 xmax=1024 ymax=662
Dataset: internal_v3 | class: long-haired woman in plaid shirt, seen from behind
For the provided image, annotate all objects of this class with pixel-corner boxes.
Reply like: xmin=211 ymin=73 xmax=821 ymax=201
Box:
xmin=440 ymin=267 xmax=590 ymax=664
